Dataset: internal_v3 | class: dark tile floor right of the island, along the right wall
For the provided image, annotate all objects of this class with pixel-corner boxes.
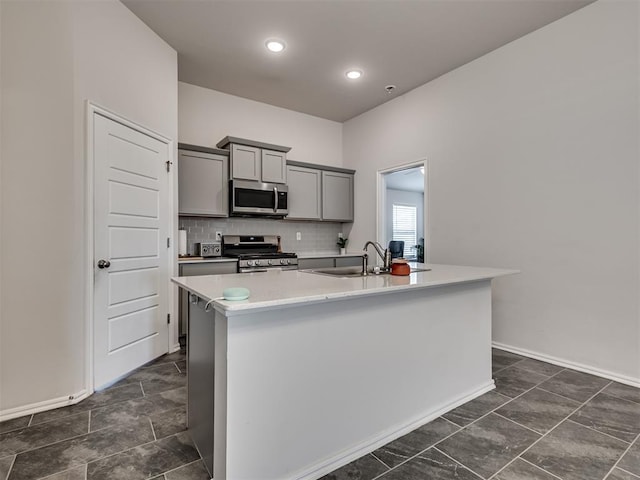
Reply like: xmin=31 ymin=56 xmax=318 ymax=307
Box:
xmin=322 ymin=350 xmax=640 ymax=480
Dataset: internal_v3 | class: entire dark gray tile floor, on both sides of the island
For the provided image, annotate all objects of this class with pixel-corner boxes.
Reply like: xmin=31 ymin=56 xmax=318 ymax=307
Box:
xmin=0 ymin=350 xmax=640 ymax=480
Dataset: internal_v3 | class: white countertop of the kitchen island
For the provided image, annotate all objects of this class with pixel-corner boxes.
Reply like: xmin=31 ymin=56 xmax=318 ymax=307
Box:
xmin=171 ymin=264 xmax=519 ymax=315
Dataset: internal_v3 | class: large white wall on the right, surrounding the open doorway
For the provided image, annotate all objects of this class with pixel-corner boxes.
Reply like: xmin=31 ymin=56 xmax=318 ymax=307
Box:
xmin=344 ymin=0 xmax=640 ymax=382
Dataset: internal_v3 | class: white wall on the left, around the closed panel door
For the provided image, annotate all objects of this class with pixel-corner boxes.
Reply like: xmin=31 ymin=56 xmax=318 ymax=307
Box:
xmin=0 ymin=0 xmax=177 ymax=415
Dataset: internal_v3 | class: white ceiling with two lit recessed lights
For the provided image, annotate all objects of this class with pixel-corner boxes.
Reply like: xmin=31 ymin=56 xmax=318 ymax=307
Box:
xmin=122 ymin=0 xmax=593 ymax=122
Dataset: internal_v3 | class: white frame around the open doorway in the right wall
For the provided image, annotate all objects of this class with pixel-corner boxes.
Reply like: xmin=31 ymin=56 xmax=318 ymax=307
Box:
xmin=376 ymin=158 xmax=431 ymax=263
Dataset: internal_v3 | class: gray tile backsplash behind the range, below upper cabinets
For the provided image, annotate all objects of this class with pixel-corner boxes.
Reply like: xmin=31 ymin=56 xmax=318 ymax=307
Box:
xmin=178 ymin=217 xmax=342 ymax=255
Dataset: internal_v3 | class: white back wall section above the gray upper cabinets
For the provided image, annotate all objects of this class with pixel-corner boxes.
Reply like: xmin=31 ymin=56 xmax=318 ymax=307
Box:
xmin=178 ymin=82 xmax=342 ymax=167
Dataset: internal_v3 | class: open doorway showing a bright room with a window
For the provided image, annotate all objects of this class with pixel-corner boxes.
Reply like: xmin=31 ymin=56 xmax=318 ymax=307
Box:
xmin=377 ymin=160 xmax=427 ymax=263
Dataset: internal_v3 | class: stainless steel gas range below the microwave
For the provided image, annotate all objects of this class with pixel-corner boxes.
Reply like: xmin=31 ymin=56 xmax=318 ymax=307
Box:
xmin=222 ymin=235 xmax=298 ymax=273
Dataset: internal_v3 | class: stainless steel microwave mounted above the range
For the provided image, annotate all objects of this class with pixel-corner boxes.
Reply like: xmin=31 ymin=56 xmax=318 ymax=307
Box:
xmin=229 ymin=180 xmax=289 ymax=217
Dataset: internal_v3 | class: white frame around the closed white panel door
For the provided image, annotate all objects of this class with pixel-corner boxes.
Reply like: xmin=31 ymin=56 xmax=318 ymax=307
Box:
xmin=85 ymin=100 xmax=177 ymax=394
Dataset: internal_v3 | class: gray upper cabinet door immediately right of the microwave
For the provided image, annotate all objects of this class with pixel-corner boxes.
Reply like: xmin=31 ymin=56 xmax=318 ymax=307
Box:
xmin=287 ymin=165 xmax=322 ymax=220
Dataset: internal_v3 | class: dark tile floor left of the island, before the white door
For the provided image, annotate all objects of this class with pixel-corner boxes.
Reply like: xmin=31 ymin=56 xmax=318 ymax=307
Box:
xmin=0 ymin=352 xmax=209 ymax=480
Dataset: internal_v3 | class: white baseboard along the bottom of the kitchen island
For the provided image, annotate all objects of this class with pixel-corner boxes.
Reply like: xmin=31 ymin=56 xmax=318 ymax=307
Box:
xmin=293 ymin=380 xmax=496 ymax=480
